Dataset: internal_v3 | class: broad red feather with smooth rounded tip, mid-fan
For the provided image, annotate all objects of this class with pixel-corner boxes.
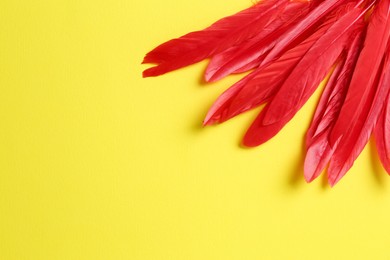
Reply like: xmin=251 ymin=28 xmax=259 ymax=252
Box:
xmin=244 ymin=8 xmax=364 ymax=146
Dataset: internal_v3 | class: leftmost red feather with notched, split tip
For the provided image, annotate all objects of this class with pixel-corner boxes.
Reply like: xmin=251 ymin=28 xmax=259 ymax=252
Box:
xmin=143 ymin=0 xmax=288 ymax=77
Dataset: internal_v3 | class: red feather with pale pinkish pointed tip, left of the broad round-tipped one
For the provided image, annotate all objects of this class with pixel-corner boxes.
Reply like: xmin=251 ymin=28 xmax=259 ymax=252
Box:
xmin=204 ymin=16 xmax=337 ymax=125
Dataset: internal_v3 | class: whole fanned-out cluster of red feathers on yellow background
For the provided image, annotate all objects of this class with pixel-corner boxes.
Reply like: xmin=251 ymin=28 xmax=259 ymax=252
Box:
xmin=143 ymin=0 xmax=390 ymax=186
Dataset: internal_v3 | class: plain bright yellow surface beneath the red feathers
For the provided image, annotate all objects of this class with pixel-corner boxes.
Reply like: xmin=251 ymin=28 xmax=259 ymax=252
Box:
xmin=0 ymin=0 xmax=390 ymax=260
